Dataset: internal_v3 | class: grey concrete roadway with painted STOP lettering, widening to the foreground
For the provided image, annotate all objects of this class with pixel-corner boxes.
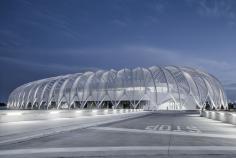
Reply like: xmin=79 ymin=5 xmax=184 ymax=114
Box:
xmin=0 ymin=112 xmax=236 ymax=157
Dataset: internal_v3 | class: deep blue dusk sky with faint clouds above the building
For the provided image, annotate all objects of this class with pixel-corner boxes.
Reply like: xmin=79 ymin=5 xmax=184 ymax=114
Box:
xmin=0 ymin=0 xmax=236 ymax=101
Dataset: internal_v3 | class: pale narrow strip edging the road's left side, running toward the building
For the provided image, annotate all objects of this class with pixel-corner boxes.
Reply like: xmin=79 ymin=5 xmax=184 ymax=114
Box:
xmin=0 ymin=113 xmax=147 ymax=145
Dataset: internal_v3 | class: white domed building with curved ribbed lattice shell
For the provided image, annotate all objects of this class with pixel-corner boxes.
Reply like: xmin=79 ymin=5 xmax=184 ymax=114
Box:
xmin=8 ymin=66 xmax=227 ymax=110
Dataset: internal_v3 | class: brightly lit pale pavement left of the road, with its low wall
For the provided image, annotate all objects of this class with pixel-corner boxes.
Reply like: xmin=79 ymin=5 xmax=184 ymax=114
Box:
xmin=0 ymin=111 xmax=148 ymax=145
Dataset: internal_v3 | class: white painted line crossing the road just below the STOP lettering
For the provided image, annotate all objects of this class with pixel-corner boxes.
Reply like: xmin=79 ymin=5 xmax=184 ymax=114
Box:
xmin=89 ymin=127 xmax=236 ymax=139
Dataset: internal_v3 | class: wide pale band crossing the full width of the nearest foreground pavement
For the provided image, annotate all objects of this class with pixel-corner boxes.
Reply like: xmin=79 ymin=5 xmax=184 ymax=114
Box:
xmin=0 ymin=146 xmax=236 ymax=156
